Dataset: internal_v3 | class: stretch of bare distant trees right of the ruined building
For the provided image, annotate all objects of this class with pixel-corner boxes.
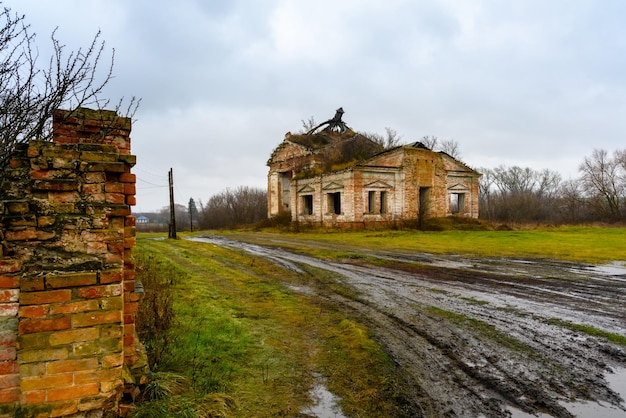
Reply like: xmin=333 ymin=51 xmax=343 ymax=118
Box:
xmin=478 ymin=149 xmax=626 ymax=224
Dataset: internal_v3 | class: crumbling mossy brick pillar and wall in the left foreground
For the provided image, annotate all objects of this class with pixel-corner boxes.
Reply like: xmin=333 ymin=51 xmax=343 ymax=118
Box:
xmin=0 ymin=109 xmax=139 ymax=417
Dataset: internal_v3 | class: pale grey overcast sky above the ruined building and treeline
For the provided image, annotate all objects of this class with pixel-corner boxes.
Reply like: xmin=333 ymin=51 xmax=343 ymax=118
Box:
xmin=4 ymin=0 xmax=626 ymax=212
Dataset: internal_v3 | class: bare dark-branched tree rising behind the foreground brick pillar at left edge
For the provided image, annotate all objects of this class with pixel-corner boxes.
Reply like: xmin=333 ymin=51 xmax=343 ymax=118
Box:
xmin=0 ymin=3 xmax=139 ymax=169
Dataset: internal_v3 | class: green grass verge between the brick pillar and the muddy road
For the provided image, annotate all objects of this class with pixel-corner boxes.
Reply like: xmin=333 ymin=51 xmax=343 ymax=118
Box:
xmin=136 ymin=236 xmax=404 ymax=417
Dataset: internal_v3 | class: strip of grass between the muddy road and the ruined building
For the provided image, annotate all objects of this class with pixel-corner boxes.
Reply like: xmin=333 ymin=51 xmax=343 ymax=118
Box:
xmin=220 ymin=226 xmax=626 ymax=263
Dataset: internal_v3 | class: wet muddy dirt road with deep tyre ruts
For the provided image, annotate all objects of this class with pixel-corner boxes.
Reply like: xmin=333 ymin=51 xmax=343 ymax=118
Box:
xmin=191 ymin=237 xmax=626 ymax=417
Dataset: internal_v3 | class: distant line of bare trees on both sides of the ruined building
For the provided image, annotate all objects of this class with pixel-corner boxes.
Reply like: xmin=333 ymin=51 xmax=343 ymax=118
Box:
xmin=138 ymin=149 xmax=626 ymax=231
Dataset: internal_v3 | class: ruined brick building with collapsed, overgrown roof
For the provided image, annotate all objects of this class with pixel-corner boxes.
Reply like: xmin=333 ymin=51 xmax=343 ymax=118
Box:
xmin=267 ymin=109 xmax=480 ymax=227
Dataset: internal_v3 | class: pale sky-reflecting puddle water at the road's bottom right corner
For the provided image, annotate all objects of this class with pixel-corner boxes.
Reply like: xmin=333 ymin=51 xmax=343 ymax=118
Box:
xmin=508 ymin=369 xmax=626 ymax=418
